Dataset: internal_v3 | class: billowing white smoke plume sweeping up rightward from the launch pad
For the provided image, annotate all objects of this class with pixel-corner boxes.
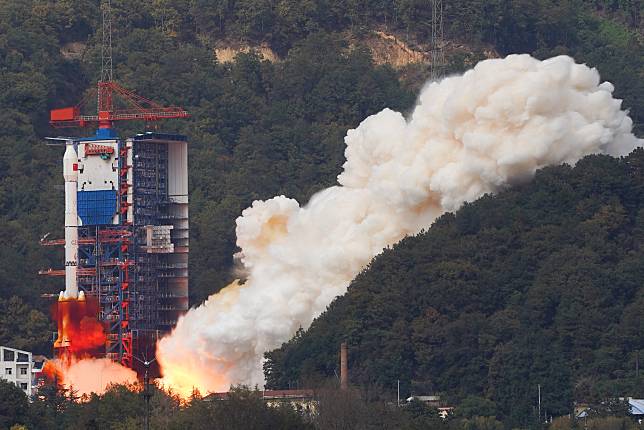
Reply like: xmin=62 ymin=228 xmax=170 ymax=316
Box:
xmin=158 ymin=55 xmax=642 ymax=393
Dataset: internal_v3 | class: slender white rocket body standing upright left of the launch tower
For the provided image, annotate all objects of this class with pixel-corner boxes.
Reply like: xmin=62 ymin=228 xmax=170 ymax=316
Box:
xmin=63 ymin=141 xmax=78 ymax=299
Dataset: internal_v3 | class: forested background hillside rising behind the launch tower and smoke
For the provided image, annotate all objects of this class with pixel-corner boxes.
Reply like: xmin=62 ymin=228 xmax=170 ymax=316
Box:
xmin=0 ymin=0 xmax=644 ymax=353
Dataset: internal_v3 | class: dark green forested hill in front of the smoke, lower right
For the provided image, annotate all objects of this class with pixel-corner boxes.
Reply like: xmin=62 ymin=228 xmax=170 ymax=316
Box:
xmin=265 ymin=149 xmax=644 ymax=428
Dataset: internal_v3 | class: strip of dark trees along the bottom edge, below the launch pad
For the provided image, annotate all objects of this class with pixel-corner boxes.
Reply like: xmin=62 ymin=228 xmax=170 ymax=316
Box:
xmin=0 ymin=380 xmax=639 ymax=430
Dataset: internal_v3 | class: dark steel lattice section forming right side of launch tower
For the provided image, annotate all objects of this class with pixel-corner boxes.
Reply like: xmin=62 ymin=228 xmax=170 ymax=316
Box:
xmin=133 ymin=135 xmax=188 ymax=346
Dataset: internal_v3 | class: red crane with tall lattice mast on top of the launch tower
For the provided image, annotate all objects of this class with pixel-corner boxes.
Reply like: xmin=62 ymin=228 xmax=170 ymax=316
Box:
xmin=49 ymin=0 xmax=190 ymax=133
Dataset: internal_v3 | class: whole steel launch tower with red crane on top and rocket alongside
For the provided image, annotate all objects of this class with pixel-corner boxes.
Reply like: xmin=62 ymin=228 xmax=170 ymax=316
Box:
xmin=42 ymin=1 xmax=189 ymax=367
